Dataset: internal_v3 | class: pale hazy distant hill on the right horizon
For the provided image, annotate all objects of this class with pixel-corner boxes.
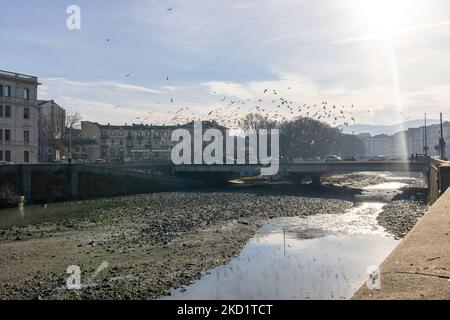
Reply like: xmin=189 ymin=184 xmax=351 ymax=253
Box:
xmin=342 ymin=119 xmax=439 ymax=136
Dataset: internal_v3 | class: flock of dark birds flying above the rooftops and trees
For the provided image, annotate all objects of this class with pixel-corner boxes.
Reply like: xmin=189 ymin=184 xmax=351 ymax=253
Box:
xmin=106 ymin=8 xmax=362 ymax=129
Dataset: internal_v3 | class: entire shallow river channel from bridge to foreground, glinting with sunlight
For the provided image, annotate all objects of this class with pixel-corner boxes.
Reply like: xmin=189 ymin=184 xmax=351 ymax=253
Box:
xmin=162 ymin=177 xmax=414 ymax=300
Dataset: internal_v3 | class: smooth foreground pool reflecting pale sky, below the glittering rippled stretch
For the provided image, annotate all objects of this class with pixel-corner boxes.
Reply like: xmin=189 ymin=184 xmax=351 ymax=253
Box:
xmin=165 ymin=221 xmax=397 ymax=300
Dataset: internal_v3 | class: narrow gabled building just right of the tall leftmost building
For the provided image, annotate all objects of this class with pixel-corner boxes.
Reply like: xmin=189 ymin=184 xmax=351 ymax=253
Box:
xmin=38 ymin=100 xmax=66 ymax=163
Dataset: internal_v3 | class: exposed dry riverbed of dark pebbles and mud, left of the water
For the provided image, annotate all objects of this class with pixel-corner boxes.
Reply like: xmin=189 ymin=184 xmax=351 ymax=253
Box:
xmin=0 ymin=172 xmax=428 ymax=299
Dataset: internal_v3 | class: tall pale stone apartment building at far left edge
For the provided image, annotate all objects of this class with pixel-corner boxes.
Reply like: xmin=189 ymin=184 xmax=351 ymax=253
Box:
xmin=0 ymin=70 xmax=39 ymax=164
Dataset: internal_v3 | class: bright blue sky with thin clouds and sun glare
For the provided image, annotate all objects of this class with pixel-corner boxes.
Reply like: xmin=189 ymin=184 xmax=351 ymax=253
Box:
xmin=0 ymin=0 xmax=450 ymax=124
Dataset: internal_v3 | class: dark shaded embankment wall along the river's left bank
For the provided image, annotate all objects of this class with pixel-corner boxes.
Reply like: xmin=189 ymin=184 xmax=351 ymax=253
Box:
xmin=0 ymin=164 xmax=204 ymax=206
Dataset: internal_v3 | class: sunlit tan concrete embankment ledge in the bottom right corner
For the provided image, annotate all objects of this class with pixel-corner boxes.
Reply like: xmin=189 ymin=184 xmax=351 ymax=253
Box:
xmin=353 ymin=189 xmax=450 ymax=300
